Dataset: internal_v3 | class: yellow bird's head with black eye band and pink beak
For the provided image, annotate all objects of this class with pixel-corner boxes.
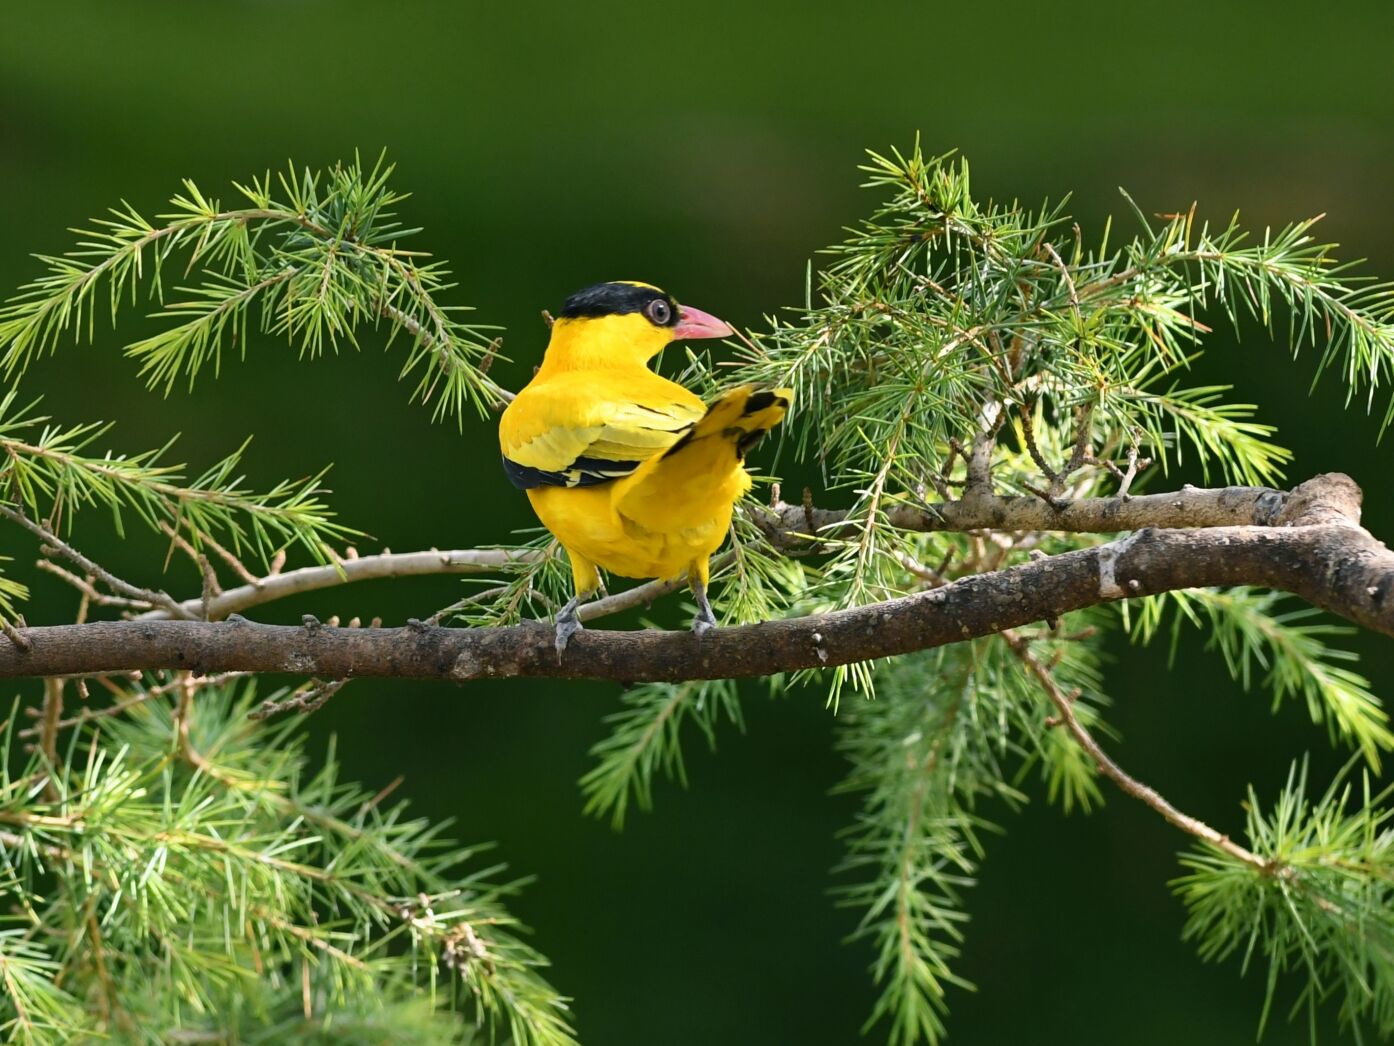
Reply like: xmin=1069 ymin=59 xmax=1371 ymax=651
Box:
xmin=546 ymin=280 xmax=735 ymax=367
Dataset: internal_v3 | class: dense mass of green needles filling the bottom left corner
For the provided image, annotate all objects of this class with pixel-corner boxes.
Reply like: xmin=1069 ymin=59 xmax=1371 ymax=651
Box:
xmin=0 ymin=681 xmax=572 ymax=1046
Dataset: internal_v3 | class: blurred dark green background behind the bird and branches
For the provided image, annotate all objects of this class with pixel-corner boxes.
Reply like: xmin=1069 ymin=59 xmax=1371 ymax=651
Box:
xmin=0 ymin=0 xmax=1394 ymax=1046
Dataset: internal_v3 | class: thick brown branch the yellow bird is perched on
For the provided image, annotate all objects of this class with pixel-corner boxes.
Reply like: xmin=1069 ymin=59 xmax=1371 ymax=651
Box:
xmin=0 ymin=474 xmax=1377 ymax=682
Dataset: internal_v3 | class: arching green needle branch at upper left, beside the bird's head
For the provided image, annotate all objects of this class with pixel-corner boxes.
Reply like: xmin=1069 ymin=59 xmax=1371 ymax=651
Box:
xmin=0 ymin=152 xmax=509 ymax=421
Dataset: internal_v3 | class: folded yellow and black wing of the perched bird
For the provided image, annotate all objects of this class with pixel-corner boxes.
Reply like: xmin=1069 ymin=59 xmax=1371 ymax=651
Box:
xmin=499 ymin=374 xmax=704 ymax=490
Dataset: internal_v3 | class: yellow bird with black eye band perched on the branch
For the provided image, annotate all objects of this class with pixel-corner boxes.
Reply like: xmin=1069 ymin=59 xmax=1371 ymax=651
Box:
xmin=499 ymin=282 xmax=793 ymax=653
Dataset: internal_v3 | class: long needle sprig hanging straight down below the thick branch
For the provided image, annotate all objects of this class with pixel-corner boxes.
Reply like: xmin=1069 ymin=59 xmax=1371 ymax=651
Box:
xmin=836 ymin=644 xmax=1020 ymax=1043
